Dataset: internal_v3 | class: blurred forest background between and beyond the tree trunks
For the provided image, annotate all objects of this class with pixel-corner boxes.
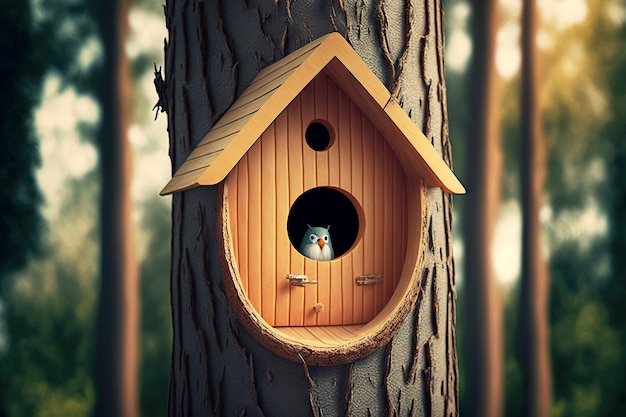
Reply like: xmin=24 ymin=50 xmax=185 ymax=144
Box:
xmin=0 ymin=0 xmax=626 ymax=417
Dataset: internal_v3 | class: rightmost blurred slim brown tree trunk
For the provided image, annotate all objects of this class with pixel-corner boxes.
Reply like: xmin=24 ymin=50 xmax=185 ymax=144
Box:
xmin=518 ymin=0 xmax=552 ymax=417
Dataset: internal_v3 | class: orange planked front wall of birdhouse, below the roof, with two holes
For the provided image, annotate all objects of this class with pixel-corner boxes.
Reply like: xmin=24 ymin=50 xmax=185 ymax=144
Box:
xmin=224 ymin=73 xmax=415 ymax=327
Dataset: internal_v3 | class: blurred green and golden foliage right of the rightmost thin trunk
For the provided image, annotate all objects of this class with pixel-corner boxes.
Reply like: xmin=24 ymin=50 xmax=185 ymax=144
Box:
xmin=546 ymin=1 xmax=626 ymax=416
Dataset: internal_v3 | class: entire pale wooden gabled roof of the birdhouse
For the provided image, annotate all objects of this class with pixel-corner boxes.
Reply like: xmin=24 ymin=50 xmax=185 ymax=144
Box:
xmin=161 ymin=33 xmax=465 ymax=195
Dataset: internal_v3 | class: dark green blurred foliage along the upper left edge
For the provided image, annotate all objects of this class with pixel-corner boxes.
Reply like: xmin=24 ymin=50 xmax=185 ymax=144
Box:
xmin=0 ymin=0 xmax=44 ymax=278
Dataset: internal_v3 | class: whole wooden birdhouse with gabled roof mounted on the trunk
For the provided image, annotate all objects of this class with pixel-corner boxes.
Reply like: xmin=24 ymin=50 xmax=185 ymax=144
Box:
xmin=162 ymin=33 xmax=465 ymax=365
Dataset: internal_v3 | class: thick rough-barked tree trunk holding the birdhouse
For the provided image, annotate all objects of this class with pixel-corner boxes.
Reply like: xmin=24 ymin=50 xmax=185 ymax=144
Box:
xmin=164 ymin=0 xmax=458 ymax=416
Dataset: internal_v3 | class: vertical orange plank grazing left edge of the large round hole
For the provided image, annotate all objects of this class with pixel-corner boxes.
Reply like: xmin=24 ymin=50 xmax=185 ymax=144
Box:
xmin=274 ymin=112 xmax=291 ymax=326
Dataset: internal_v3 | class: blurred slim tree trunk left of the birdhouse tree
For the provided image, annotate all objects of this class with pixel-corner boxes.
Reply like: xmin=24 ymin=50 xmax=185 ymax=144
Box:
xmin=94 ymin=0 xmax=139 ymax=417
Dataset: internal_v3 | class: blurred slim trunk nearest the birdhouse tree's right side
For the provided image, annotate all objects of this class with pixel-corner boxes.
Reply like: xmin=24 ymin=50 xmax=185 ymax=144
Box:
xmin=463 ymin=0 xmax=504 ymax=417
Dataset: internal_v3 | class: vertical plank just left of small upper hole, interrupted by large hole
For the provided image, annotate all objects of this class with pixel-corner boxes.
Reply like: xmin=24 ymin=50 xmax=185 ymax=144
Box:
xmin=287 ymin=97 xmax=304 ymax=326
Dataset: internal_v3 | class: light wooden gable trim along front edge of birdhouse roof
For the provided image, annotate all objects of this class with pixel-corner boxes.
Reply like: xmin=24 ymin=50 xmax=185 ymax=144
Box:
xmin=160 ymin=33 xmax=465 ymax=195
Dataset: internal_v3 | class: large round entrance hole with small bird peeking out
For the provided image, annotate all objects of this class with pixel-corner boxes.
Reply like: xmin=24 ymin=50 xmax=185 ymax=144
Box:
xmin=287 ymin=187 xmax=360 ymax=260
